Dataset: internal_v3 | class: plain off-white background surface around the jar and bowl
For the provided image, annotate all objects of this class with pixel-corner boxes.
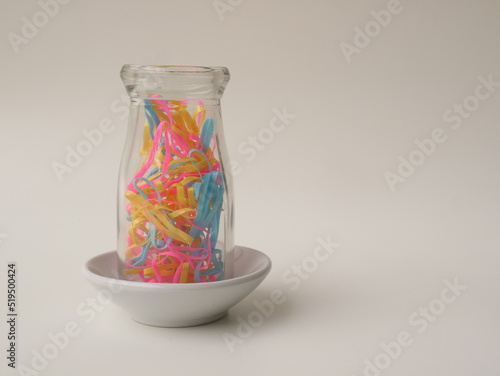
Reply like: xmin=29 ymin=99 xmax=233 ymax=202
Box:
xmin=0 ymin=0 xmax=500 ymax=376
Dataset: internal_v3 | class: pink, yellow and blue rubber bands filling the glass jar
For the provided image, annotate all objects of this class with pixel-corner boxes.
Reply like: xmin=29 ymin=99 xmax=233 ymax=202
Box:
xmin=124 ymin=96 xmax=224 ymax=283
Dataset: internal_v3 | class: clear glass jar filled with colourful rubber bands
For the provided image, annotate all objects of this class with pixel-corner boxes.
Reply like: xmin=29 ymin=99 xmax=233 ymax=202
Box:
xmin=118 ymin=65 xmax=234 ymax=283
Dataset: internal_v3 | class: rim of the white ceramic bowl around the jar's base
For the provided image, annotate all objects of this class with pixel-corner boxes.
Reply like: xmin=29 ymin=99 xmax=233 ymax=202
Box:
xmin=82 ymin=245 xmax=272 ymax=291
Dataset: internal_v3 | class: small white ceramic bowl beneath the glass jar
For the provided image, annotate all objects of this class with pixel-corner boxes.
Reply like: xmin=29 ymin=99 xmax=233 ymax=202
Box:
xmin=83 ymin=246 xmax=271 ymax=327
